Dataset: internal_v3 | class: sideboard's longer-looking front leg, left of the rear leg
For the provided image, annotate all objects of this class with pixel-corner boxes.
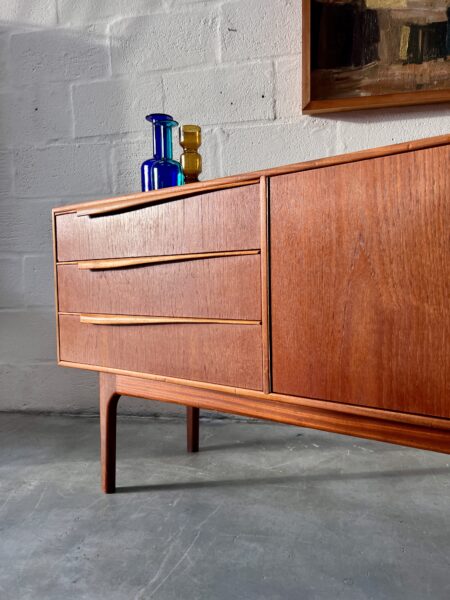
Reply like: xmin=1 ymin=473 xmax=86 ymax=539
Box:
xmin=100 ymin=373 xmax=120 ymax=494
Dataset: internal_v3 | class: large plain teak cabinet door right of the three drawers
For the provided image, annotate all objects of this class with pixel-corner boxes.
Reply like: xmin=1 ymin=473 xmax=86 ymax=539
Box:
xmin=270 ymin=146 xmax=450 ymax=417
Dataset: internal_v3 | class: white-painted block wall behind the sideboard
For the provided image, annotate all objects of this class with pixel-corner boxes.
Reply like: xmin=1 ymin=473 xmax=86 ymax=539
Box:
xmin=0 ymin=0 xmax=450 ymax=412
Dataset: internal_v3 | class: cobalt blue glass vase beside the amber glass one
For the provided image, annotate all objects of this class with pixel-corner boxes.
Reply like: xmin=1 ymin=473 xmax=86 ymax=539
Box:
xmin=141 ymin=113 xmax=184 ymax=192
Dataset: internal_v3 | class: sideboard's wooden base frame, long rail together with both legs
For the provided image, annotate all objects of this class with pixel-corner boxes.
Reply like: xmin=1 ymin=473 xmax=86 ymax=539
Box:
xmin=93 ymin=373 xmax=450 ymax=493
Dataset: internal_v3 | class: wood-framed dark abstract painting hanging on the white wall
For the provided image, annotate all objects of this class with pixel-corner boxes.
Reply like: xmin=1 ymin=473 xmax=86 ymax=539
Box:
xmin=302 ymin=0 xmax=450 ymax=114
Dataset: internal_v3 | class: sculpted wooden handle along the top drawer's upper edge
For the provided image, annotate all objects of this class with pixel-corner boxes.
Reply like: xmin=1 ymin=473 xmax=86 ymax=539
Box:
xmin=77 ymin=177 xmax=259 ymax=217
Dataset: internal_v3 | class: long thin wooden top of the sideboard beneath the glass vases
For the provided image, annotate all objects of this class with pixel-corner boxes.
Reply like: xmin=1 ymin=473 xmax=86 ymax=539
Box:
xmin=53 ymin=134 xmax=450 ymax=216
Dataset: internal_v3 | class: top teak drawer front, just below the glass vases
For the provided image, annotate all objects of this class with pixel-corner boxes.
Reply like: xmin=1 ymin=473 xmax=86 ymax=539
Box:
xmin=56 ymin=185 xmax=260 ymax=261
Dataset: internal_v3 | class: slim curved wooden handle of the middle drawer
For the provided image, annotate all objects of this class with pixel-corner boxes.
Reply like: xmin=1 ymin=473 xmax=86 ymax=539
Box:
xmin=77 ymin=250 xmax=260 ymax=271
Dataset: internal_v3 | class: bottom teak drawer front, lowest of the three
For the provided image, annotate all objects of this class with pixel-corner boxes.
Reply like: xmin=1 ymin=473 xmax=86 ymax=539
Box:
xmin=59 ymin=315 xmax=262 ymax=390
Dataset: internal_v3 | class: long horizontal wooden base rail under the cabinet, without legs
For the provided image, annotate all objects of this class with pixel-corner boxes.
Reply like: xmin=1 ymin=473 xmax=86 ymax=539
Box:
xmin=115 ymin=375 xmax=450 ymax=454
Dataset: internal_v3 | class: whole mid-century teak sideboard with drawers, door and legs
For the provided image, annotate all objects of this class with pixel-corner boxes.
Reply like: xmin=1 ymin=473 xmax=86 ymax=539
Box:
xmin=53 ymin=135 xmax=450 ymax=492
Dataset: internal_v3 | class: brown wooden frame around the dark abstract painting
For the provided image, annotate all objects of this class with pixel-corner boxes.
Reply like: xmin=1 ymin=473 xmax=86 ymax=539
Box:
xmin=302 ymin=0 xmax=450 ymax=115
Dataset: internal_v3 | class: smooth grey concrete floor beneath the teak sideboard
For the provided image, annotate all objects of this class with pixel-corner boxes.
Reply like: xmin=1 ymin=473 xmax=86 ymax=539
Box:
xmin=0 ymin=413 xmax=450 ymax=600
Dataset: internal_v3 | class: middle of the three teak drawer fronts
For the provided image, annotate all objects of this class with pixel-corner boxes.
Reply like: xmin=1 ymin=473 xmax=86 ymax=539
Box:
xmin=57 ymin=254 xmax=261 ymax=321
